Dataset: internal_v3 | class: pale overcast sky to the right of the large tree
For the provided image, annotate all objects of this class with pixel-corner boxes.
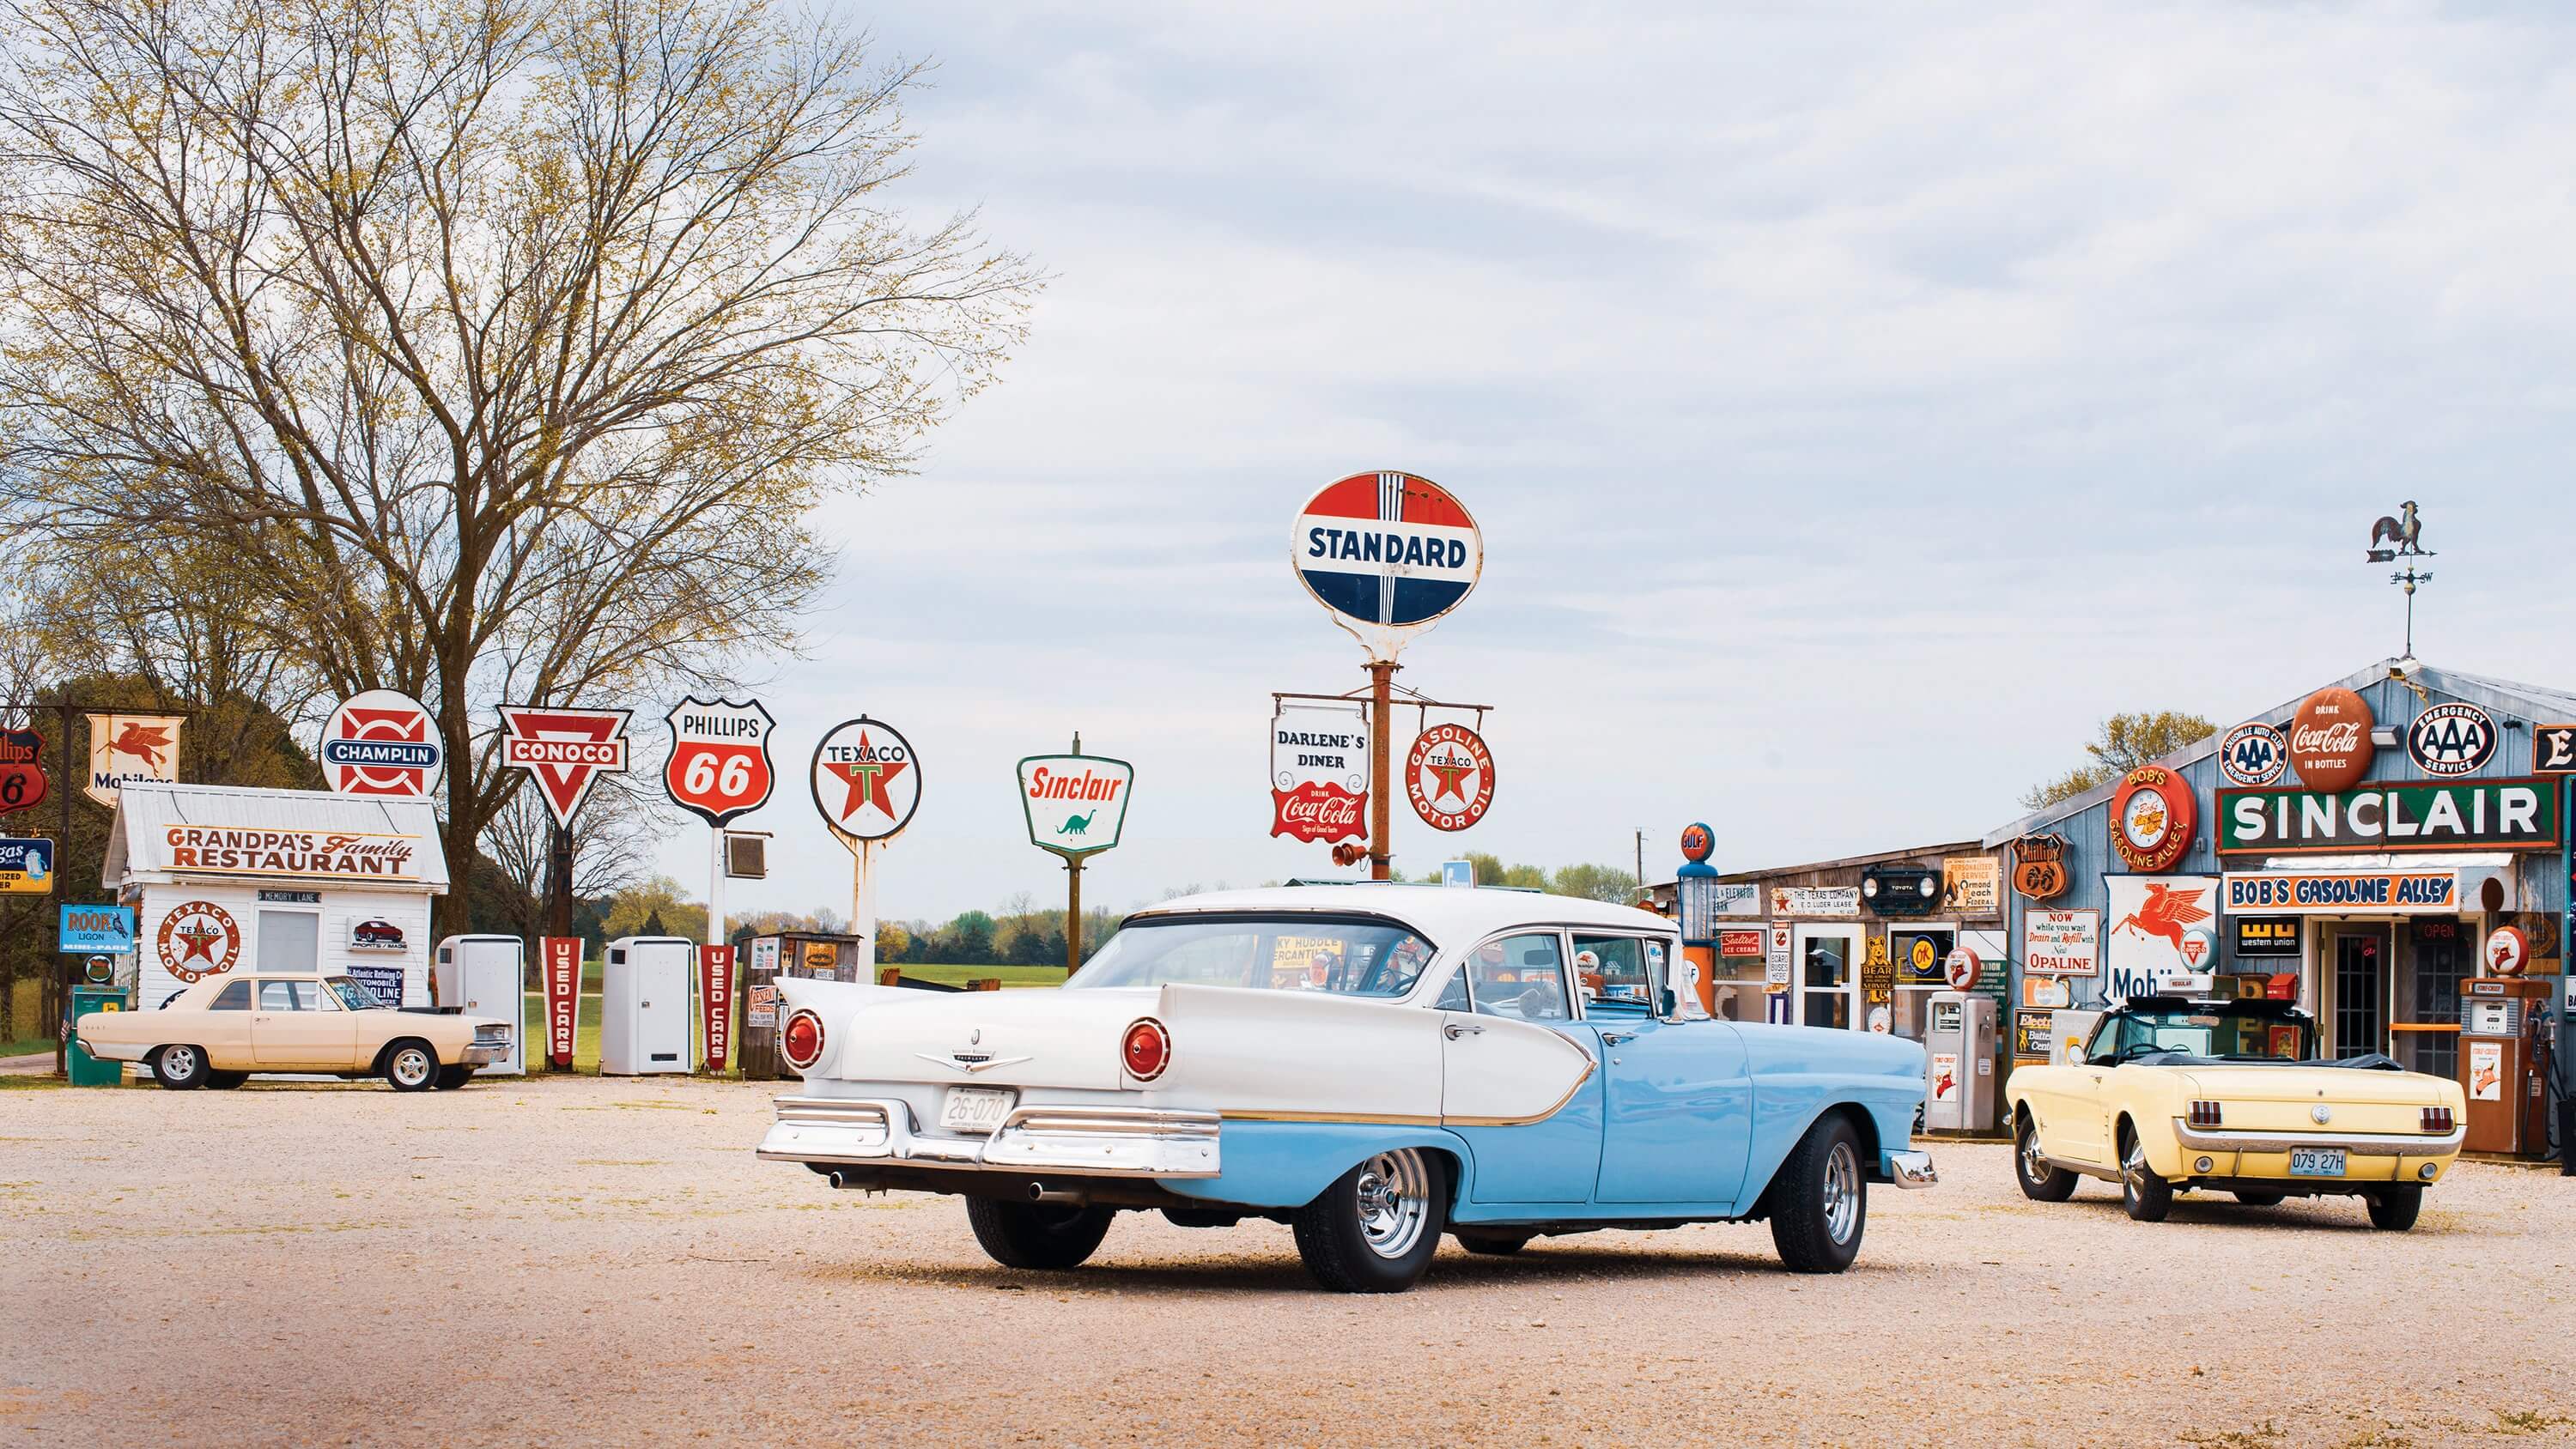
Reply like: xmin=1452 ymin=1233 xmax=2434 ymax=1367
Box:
xmin=654 ymin=0 xmax=2576 ymax=919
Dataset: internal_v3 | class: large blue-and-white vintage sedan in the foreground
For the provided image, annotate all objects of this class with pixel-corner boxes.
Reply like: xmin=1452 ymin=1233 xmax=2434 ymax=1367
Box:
xmin=760 ymin=885 xmax=1932 ymax=1292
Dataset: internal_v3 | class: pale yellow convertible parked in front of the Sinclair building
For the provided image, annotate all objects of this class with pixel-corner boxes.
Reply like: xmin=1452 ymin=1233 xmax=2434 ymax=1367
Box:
xmin=2004 ymin=996 xmax=2468 ymax=1233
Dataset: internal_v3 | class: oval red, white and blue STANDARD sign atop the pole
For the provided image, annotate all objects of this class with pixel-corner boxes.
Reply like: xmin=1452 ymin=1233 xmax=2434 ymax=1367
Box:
xmin=1288 ymin=474 xmax=1484 ymax=628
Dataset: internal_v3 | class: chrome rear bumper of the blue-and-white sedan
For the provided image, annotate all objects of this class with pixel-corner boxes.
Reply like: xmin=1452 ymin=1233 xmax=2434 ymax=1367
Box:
xmin=760 ymin=1096 xmax=1218 ymax=1179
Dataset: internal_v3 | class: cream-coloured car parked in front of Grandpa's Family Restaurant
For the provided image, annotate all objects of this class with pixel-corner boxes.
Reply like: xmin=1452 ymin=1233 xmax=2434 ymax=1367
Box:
xmin=72 ymin=973 xmax=510 ymax=1091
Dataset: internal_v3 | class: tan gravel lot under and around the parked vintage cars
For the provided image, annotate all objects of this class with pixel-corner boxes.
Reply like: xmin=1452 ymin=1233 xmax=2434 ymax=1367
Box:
xmin=0 ymin=1078 xmax=2576 ymax=1446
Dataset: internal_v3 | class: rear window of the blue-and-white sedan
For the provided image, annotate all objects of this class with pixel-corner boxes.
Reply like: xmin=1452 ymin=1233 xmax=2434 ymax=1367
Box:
xmin=1064 ymin=911 xmax=1432 ymax=996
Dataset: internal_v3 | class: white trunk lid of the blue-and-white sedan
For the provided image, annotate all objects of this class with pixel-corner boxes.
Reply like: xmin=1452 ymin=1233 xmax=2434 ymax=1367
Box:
xmin=832 ymin=988 xmax=1159 ymax=1091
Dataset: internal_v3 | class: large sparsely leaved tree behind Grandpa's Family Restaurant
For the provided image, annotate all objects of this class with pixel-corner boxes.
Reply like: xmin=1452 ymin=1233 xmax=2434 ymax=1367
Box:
xmin=0 ymin=0 xmax=1038 ymax=931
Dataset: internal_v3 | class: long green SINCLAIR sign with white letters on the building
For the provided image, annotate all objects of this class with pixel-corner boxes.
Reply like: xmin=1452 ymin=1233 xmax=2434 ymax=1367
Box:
xmin=2218 ymin=779 xmax=2558 ymax=854
